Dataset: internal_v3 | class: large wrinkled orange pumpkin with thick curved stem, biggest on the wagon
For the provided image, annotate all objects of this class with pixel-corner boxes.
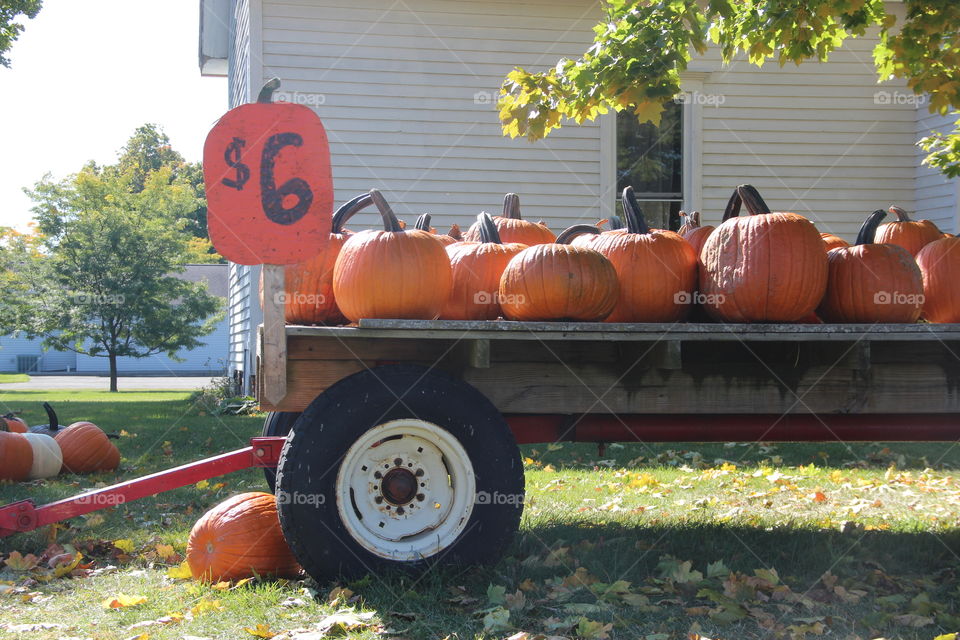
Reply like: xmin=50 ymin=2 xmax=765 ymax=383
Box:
xmin=700 ymin=185 xmax=827 ymax=322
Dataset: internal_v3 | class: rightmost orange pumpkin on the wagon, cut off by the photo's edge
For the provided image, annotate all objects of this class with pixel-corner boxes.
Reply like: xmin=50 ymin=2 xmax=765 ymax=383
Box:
xmin=917 ymin=238 xmax=960 ymax=323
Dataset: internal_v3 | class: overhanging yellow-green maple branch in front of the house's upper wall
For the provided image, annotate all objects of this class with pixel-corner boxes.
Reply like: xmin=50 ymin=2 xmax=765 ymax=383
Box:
xmin=498 ymin=0 xmax=960 ymax=176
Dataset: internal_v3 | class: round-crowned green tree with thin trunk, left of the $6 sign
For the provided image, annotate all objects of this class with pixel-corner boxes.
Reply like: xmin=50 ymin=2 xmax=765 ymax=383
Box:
xmin=14 ymin=158 xmax=221 ymax=391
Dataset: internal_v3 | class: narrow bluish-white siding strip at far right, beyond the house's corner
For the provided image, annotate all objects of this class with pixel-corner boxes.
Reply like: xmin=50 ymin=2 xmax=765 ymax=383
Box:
xmin=915 ymin=110 xmax=960 ymax=233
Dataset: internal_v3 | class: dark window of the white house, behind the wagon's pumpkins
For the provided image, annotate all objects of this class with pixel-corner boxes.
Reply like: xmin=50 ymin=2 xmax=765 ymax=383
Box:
xmin=617 ymin=101 xmax=683 ymax=230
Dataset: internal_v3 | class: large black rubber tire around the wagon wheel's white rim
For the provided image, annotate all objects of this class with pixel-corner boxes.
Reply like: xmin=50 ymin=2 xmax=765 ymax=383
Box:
xmin=277 ymin=365 xmax=524 ymax=581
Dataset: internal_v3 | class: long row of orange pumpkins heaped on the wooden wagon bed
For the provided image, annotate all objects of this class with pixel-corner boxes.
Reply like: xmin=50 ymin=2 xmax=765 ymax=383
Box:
xmin=270 ymin=185 xmax=960 ymax=325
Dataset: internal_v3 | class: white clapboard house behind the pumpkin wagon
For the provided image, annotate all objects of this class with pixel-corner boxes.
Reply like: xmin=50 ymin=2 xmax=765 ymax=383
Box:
xmin=200 ymin=0 xmax=960 ymax=396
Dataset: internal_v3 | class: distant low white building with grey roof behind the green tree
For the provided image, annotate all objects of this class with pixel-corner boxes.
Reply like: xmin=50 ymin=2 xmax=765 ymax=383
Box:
xmin=0 ymin=264 xmax=229 ymax=376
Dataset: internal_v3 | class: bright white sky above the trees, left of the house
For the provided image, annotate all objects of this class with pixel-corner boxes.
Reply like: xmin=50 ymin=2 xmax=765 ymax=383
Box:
xmin=0 ymin=0 xmax=227 ymax=228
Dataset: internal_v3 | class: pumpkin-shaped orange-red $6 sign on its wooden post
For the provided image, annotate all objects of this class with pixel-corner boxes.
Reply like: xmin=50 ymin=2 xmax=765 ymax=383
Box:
xmin=203 ymin=78 xmax=333 ymax=404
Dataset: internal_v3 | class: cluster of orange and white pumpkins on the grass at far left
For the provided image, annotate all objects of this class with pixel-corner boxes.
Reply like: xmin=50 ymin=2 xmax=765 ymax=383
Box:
xmin=0 ymin=403 xmax=120 ymax=482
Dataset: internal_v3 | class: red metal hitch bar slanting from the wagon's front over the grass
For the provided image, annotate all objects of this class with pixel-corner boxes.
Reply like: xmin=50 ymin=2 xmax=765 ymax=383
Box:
xmin=0 ymin=437 xmax=286 ymax=538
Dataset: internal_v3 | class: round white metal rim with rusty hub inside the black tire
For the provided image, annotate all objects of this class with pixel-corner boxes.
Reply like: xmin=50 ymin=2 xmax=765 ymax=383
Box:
xmin=336 ymin=418 xmax=476 ymax=562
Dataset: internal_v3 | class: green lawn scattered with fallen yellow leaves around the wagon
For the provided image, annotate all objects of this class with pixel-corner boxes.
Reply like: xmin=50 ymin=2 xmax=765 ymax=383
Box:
xmin=0 ymin=391 xmax=960 ymax=640
